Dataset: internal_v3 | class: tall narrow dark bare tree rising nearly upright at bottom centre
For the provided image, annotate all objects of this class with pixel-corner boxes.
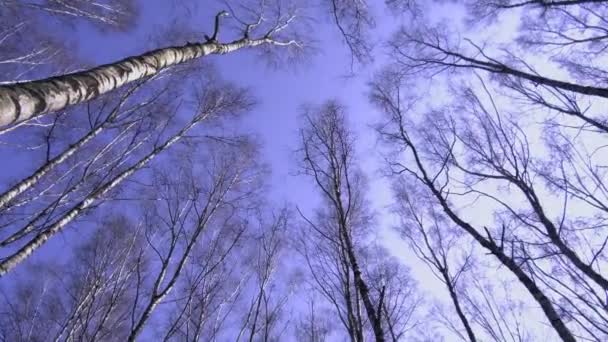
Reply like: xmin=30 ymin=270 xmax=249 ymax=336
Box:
xmin=300 ymin=102 xmax=385 ymax=341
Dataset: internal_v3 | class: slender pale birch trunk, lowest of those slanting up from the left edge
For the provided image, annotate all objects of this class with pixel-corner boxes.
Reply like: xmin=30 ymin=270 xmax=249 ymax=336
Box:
xmin=0 ymin=118 xmax=200 ymax=277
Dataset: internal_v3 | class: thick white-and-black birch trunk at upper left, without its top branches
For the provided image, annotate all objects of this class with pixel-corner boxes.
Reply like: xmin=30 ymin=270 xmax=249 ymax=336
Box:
xmin=0 ymin=37 xmax=276 ymax=127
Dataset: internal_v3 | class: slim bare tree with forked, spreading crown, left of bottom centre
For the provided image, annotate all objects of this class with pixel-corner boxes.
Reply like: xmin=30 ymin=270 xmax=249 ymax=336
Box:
xmin=128 ymin=135 xmax=260 ymax=341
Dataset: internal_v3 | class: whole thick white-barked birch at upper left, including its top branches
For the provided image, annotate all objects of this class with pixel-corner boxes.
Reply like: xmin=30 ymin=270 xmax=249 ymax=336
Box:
xmin=0 ymin=5 xmax=301 ymax=126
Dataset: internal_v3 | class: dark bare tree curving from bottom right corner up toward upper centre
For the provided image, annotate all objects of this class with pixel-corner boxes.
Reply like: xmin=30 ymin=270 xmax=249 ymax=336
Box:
xmin=371 ymin=72 xmax=576 ymax=341
